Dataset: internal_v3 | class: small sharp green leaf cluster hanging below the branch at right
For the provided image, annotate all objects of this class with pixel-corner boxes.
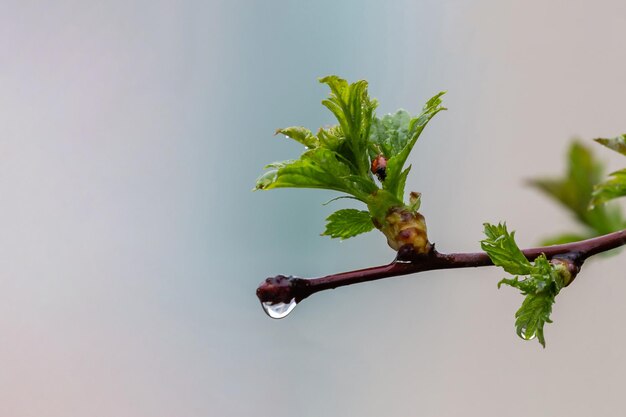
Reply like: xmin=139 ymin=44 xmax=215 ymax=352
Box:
xmin=481 ymin=223 xmax=571 ymax=347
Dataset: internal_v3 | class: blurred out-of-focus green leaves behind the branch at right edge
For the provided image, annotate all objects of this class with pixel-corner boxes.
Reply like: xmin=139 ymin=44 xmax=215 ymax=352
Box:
xmin=529 ymin=141 xmax=624 ymax=236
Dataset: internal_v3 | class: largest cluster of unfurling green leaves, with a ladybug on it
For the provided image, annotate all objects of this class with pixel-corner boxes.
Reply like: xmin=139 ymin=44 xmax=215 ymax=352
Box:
xmin=255 ymin=75 xmax=445 ymax=247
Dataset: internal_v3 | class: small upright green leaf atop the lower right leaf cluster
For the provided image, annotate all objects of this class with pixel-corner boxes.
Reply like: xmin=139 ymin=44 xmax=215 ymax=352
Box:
xmin=480 ymin=223 xmax=532 ymax=275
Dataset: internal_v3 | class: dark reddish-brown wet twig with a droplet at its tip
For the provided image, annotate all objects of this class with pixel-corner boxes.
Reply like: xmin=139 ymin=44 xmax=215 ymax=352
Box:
xmin=256 ymin=229 xmax=626 ymax=304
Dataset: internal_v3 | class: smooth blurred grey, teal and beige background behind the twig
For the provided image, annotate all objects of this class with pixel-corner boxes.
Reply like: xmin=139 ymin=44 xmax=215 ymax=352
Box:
xmin=0 ymin=0 xmax=626 ymax=417
